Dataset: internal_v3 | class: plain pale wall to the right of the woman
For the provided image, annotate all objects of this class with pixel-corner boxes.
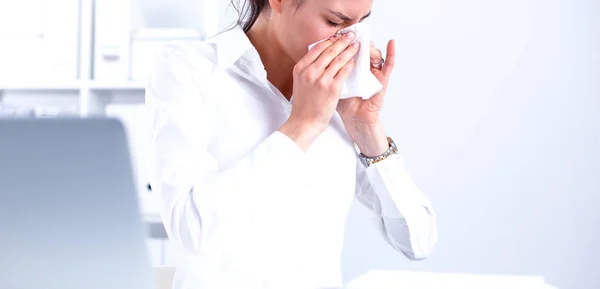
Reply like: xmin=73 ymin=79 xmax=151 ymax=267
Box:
xmin=344 ymin=0 xmax=600 ymax=289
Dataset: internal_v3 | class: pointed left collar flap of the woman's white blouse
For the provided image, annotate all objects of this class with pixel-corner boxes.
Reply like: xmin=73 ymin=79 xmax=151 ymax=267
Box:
xmin=207 ymin=25 xmax=255 ymax=68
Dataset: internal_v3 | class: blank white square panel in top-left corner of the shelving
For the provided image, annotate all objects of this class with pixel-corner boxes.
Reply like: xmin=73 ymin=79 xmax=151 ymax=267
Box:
xmin=0 ymin=0 xmax=79 ymax=83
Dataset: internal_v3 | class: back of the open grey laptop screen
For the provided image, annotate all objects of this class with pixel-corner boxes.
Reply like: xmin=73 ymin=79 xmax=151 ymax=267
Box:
xmin=0 ymin=118 xmax=155 ymax=289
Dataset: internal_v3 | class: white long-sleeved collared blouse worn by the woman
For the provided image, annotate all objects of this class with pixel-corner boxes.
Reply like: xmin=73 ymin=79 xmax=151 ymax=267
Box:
xmin=146 ymin=26 xmax=437 ymax=289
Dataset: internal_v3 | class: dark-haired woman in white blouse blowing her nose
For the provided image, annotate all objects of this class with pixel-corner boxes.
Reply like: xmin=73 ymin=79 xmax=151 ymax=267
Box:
xmin=146 ymin=0 xmax=437 ymax=289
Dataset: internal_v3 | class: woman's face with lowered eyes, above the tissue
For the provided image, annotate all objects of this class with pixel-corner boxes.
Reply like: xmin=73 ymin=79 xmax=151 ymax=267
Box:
xmin=271 ymin=0 xmax=373 ymax=62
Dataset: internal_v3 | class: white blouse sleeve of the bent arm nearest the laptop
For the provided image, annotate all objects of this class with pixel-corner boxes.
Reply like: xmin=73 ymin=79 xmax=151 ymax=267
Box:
xmin=146 ymin=45 xmax=304 ymax=251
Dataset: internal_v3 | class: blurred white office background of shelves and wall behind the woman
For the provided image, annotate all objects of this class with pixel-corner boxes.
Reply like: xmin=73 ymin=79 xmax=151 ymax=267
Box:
xmin=0 ymin=0 xmax=600 ymax=289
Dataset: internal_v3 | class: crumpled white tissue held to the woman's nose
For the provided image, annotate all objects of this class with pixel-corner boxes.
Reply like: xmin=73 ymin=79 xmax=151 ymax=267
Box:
xmin=308 ymin=22 xmax=383 ymax=99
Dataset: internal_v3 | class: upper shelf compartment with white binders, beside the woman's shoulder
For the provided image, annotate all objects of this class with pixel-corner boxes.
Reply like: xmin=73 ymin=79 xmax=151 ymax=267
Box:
xmin=92 ymin=0 xmax=219 ymax=81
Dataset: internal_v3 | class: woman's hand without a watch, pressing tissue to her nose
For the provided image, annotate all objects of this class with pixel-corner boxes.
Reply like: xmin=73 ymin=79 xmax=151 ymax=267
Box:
xmin=279 ymin=32 xmax=359 ymax=151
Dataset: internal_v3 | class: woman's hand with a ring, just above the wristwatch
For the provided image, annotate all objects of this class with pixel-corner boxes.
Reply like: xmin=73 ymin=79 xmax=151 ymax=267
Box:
xmin=337 ymin=40 xmax=396 ymax=156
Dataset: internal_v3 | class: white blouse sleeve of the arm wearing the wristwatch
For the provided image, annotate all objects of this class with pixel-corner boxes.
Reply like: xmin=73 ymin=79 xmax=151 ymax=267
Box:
xmin=356 ymin=155 xmax=438 ymax=260
